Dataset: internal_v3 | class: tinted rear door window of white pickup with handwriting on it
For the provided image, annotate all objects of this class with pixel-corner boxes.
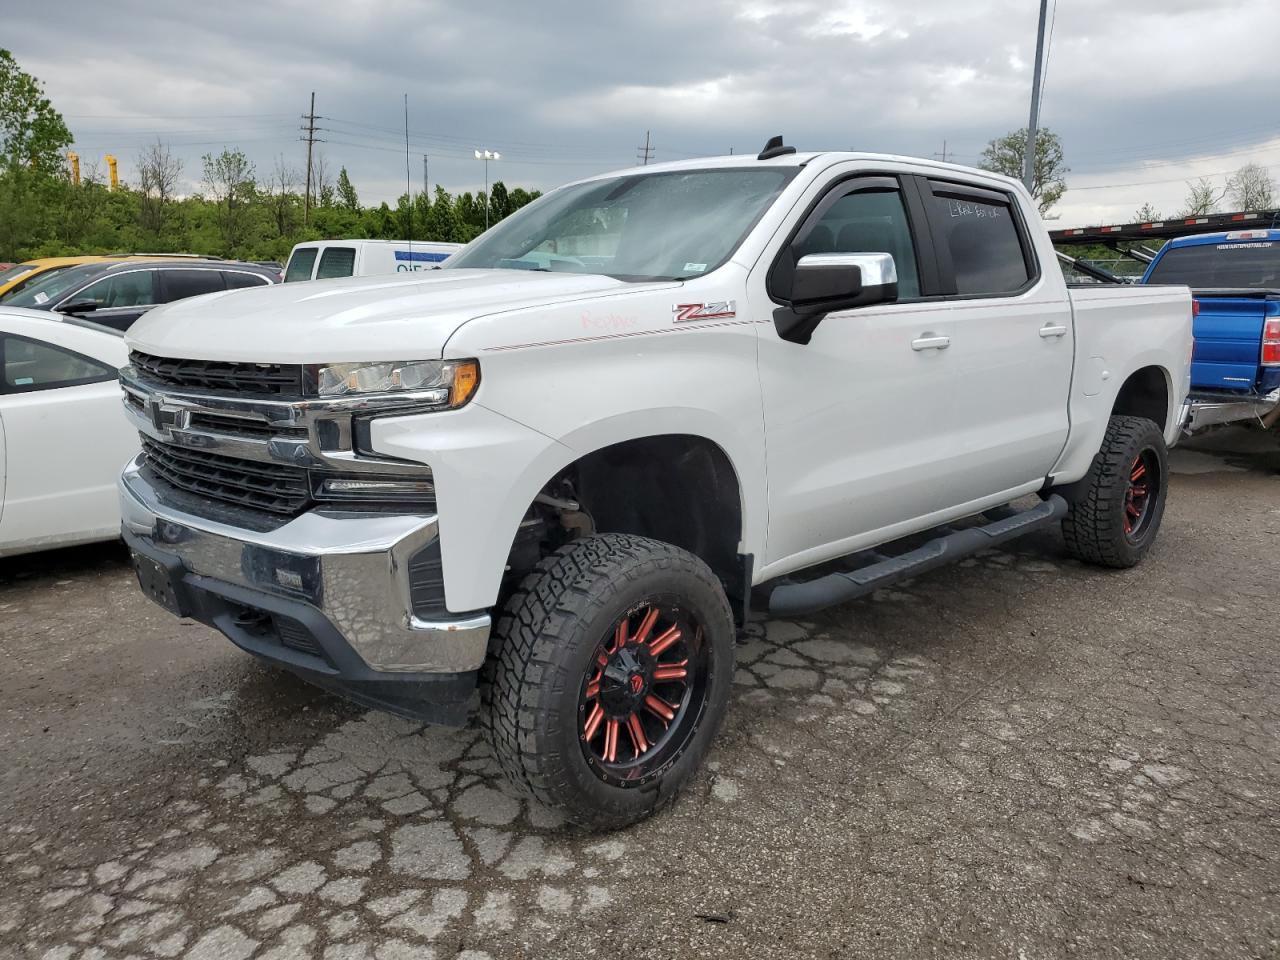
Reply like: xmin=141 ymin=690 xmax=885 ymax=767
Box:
xmin=925 ymin=184 xmax=1032 ymax=297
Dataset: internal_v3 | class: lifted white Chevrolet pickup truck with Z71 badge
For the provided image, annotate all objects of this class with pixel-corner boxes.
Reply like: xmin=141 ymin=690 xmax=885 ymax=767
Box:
xmin=120 ymin=138 xmax=1192 ymax=828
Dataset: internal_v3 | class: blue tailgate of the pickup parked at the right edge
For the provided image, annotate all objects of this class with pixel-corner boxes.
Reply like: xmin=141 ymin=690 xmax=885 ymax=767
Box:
xmin=1192 ymin=291 xmax=1280 ymax=392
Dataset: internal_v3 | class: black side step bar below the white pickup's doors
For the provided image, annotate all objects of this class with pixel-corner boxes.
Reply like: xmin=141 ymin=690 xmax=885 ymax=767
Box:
xmin=769 ymin=493 xmax=1068 ymax=617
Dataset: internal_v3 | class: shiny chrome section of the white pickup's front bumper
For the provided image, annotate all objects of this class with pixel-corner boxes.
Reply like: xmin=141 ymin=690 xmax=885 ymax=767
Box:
xmin=119 ymin=458 xmax=490 ymax=673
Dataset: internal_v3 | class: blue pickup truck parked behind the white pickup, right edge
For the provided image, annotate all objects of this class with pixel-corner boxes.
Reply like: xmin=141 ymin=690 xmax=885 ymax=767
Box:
xmin=1142 ymin=229 xmax=1280 ymax=430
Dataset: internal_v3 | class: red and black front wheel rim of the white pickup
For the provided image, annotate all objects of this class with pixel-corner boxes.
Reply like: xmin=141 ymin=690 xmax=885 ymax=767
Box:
xmin=579 ymin=600 xmax=707 ymax=786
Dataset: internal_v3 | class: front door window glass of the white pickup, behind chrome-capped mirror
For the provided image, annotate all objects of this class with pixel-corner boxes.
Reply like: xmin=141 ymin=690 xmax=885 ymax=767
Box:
xmin=796 ymin=189 xmax=920 ymax=300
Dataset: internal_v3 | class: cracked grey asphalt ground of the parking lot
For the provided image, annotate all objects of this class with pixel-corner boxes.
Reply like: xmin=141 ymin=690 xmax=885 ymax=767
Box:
xmin=0 ymin=433 xmax=1280 ymax=960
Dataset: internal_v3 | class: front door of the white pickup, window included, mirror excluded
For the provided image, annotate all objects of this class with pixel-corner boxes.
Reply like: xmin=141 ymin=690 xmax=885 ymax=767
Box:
xmin=751 ymin=177 xmax=959 ymax=568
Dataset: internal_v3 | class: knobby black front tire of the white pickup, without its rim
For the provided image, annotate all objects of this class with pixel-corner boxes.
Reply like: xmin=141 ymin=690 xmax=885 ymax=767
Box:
xmin=480 ymin=534 xmax=735 ymax=831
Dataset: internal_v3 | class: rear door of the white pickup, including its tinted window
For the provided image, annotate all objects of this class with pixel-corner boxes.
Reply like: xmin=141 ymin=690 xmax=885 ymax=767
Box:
xmin=919 ymin=178 xmax=1075 ymax=503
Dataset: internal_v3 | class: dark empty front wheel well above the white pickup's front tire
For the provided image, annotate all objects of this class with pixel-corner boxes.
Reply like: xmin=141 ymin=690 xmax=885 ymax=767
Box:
xmin=509 ymin=434 xmax=750 ymax=619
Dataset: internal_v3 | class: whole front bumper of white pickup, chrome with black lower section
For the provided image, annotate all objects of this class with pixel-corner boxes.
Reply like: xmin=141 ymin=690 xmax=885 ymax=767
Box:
xmin=119 ymin=458 xmax=490 ymax=722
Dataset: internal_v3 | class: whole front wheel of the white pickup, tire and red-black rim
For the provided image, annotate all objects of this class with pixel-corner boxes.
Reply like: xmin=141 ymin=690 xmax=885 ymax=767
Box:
xmin=483 ymin=534 xmax=733 ymax=829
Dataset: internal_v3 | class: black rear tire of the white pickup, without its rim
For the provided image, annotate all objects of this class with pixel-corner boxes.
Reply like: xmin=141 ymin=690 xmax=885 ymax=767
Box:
xmin=1062 ymin=416 xmax=1169 ymax=568
